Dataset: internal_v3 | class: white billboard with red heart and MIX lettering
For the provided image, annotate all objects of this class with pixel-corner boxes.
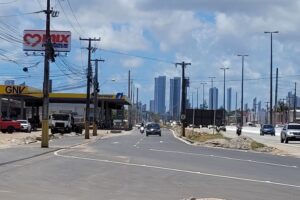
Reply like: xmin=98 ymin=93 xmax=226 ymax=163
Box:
xmin=23 ymin=30 xmax=71 ymax=52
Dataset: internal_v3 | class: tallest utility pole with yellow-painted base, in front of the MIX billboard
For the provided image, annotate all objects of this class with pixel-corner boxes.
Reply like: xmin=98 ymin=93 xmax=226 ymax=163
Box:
xmin=41 ymin=0 xmax=54 ymax=148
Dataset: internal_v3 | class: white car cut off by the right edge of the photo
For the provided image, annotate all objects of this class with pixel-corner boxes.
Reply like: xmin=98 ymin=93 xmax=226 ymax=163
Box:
xmin=280 ymin=123 xmax=300 ymax=143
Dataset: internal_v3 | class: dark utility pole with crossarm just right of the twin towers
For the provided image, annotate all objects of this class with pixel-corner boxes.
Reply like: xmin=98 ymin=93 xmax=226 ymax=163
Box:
xmin=175 ymin=61 xmax=191 ymax=137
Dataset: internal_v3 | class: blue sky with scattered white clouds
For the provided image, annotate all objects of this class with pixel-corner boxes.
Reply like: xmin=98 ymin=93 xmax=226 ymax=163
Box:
xmin=0 ymin=0 xmax=300 ymax=111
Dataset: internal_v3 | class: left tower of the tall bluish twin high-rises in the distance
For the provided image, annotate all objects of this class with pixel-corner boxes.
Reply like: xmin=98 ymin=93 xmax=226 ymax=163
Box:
xmin=154 ymin=76 xmax=166 ymax=114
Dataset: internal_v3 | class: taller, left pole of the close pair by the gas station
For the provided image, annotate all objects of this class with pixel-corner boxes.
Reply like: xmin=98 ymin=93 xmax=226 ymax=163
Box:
xmin=79 ymin=38 xmax=100 ymax=139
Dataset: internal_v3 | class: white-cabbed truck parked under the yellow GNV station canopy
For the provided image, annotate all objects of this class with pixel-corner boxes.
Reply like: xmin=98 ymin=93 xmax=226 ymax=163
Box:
xmin=50 ymin=113 xmax=84 ymax=134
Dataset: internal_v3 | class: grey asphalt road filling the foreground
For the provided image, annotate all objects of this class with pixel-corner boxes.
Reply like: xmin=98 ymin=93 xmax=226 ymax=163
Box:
xmin=0 ymin=130 xmax=300 ymax=200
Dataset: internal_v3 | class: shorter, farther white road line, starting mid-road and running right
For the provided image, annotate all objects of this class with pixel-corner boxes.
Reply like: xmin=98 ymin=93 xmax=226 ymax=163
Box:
xmin=149 ymin=149 xmax=298 ymax=168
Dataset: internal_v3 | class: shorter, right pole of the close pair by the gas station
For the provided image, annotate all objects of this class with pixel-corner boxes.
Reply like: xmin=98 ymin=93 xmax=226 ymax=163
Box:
xmin=91 ymin=59 xmax=104 ymax=136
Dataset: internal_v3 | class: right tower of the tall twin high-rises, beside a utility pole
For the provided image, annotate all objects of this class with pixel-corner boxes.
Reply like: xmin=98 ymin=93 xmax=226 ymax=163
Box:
xmin=169 ymin=77 xmax=181 ymax=120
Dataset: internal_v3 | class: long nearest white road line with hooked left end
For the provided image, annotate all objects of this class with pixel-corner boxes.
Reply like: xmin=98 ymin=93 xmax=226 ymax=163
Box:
xmin=54 ymin=149 xmax=300 ymax=189
